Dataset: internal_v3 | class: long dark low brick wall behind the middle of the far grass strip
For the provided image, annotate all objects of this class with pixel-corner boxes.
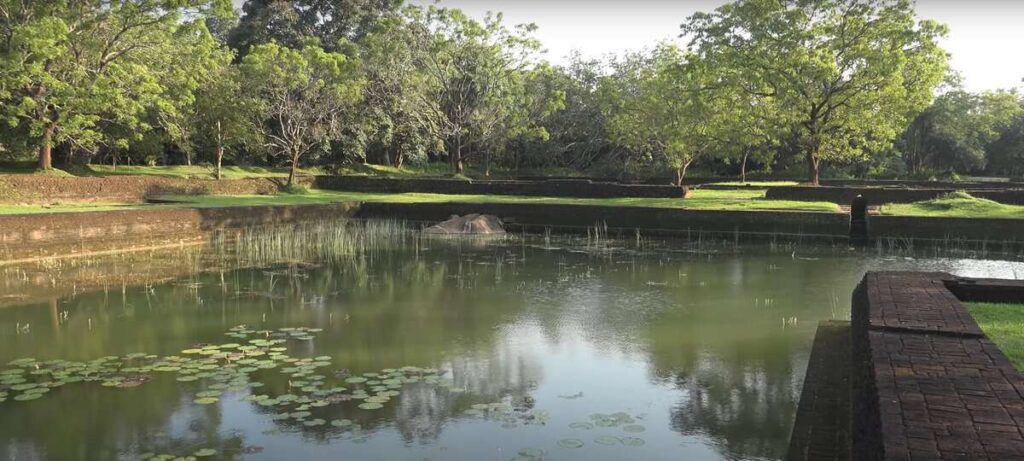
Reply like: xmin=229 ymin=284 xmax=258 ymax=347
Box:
xmin=314 ymin=176 xmax=685 ymax=199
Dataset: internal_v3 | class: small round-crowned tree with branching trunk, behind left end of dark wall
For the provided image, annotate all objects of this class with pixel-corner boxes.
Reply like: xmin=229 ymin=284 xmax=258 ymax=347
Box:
xmin=241 ymin=43 xmax=362 ymax=185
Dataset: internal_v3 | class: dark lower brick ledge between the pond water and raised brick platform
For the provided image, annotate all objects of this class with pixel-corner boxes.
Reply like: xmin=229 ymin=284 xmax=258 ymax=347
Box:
xmin=785 ymin=322 xmax=850 ymax=461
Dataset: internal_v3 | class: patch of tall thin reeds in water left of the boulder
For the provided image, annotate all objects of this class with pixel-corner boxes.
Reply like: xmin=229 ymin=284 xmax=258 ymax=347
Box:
xmin=224 ymin=219 xmax=415 ymax=265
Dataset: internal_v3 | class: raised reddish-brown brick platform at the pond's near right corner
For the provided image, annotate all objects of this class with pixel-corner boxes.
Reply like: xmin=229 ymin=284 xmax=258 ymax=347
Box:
xmin=851 ymin=273 xmax=1024 ymax=460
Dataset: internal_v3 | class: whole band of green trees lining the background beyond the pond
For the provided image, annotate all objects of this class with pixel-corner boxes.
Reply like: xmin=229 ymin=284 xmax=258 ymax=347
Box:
xmin=0 ymin=0 xmax=1024 ymax=181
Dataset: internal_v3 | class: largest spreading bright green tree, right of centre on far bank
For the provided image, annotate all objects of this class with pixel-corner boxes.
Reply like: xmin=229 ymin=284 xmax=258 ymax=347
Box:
xmin=683 ymin=0 xmax=947 ymax=184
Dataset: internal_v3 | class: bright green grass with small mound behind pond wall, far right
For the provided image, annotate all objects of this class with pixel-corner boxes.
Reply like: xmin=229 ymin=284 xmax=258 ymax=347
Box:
xmin=881 ymin=192 xmax=1024 ymax=219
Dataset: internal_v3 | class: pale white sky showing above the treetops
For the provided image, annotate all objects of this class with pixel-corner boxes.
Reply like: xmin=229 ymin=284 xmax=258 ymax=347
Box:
xmin=407 ymin=0 xmax=1024 ymax=91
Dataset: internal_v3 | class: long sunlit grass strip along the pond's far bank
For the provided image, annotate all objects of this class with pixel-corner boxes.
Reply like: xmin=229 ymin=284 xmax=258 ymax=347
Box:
xmin=0 ymin=190 xmax=840 ymax=214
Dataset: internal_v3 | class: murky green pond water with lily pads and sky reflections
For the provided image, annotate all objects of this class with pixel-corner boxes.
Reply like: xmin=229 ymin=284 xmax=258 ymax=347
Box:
xmin=0 ymin=221 xmax=1024 ymax=460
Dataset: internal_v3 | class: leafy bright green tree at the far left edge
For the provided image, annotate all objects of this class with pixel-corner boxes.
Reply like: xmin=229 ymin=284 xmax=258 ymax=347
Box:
xmin=0 ymin=0 xmax=230 ymax=169
